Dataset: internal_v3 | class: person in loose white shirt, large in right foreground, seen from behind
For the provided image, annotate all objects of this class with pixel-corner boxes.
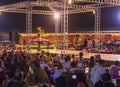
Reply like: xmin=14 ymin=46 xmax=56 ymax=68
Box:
xmin=90 ymin=60 xmax=106 ymax=85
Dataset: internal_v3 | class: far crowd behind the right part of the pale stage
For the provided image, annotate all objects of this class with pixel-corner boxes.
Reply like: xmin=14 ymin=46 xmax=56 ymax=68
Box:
xmin=74 ymin=38 xmax=120 ymax=54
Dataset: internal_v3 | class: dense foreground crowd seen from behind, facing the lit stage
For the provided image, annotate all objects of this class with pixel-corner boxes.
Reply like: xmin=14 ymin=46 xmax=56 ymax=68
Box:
xmin=0 ymin=50 xmax=120 ymax=87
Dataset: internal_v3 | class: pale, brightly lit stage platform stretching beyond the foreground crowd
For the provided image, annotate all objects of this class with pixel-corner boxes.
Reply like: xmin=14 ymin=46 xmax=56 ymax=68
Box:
xmin=31 ymin=49 xmax=120 ymax=61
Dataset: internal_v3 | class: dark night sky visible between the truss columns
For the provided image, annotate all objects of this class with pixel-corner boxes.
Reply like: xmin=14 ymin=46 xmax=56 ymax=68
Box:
xmin=0 ymin=0 xmax=120 ymax=32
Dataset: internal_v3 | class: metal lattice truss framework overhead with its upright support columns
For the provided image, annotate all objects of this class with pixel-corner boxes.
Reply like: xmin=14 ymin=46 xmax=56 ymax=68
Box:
xmin=0 ymin=0 xmax=120 ymax=52
